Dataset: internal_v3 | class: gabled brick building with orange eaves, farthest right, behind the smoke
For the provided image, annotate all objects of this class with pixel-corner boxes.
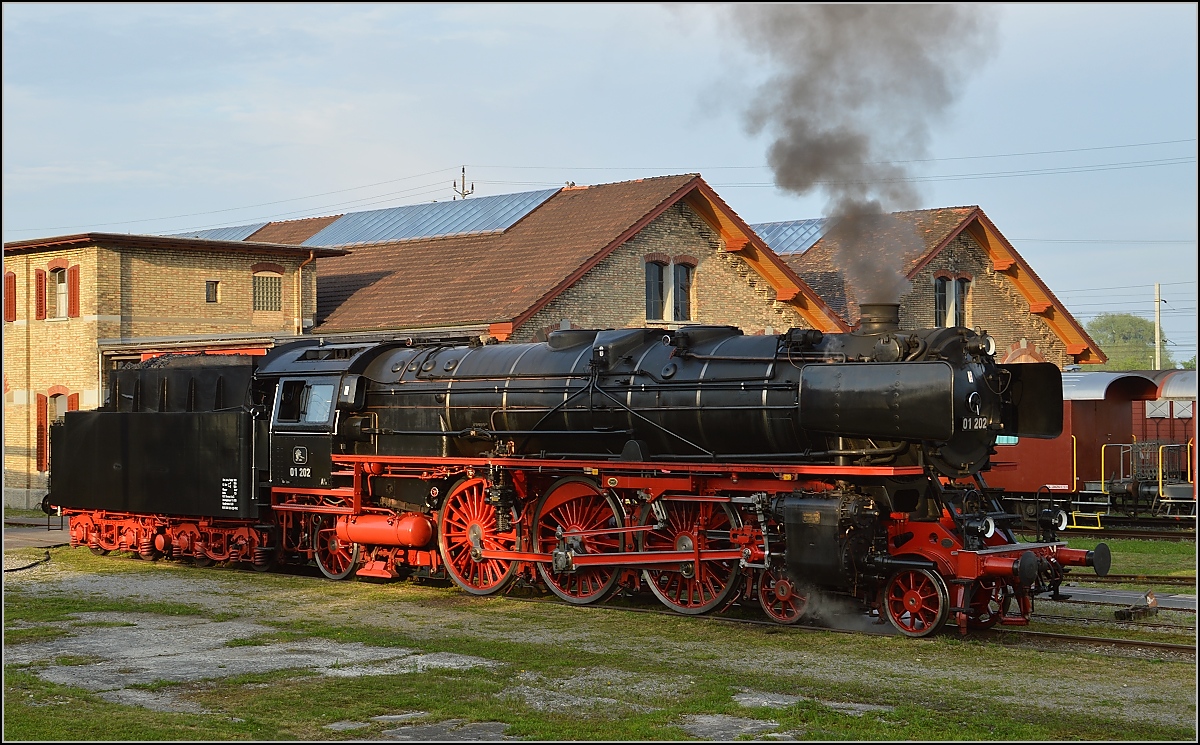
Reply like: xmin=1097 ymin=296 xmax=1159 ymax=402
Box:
xmin=751 ymin=206 xmax=1106 ymax=368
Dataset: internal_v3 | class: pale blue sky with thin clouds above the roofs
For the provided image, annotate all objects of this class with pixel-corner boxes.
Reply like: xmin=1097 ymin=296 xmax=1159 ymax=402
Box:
xmin=2 ymin=2 xmax=1198 ymax=360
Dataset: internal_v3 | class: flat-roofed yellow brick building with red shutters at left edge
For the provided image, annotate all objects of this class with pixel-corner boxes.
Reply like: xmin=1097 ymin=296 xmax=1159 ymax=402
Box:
xmin=4 ymin=233 xmax=343 ymax=507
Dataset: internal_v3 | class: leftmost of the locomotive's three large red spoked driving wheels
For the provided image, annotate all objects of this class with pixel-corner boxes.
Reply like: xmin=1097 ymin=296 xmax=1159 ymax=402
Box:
xmin=438 ymin=479 xmax=521 ymax=595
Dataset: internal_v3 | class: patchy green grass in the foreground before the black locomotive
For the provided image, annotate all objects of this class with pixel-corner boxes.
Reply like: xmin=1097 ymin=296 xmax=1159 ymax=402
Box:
xmin=4 ymin=541 xmax=1196 ymax=741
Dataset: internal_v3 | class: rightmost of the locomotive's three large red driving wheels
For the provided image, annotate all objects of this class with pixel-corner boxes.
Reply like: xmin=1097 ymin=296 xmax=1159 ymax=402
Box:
xmin=638 ymin=500 xmax=742 ymax=615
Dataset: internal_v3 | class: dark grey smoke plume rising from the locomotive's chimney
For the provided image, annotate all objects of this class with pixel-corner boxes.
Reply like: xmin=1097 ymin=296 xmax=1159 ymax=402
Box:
xmin=731 ymin=5 xmax=995 ymax=302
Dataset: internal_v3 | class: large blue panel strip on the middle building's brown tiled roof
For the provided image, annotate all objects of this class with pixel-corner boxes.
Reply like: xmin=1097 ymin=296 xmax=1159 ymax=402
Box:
xmin=301 ymin=188 xmax=558 ymax=246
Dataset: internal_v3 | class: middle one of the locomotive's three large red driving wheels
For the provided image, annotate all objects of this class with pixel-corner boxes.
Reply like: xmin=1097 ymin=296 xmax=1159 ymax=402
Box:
xmin=535 ymin=476 xmax=625 ymax=605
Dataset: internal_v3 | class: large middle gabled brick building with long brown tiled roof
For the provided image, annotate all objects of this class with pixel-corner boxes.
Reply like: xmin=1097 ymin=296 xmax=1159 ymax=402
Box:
xmin=150 ymin=174 xmax=847 ymax=341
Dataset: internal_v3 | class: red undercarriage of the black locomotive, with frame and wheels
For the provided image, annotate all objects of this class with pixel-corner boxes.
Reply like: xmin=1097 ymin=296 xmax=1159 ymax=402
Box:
xmin=65 ymin=455 xmax=1093 ymax=636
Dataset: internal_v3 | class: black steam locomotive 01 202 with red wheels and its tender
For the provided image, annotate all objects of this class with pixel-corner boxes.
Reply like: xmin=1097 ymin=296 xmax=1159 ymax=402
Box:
xmin=44 ymin=305 xmax=1110 ymax=637
